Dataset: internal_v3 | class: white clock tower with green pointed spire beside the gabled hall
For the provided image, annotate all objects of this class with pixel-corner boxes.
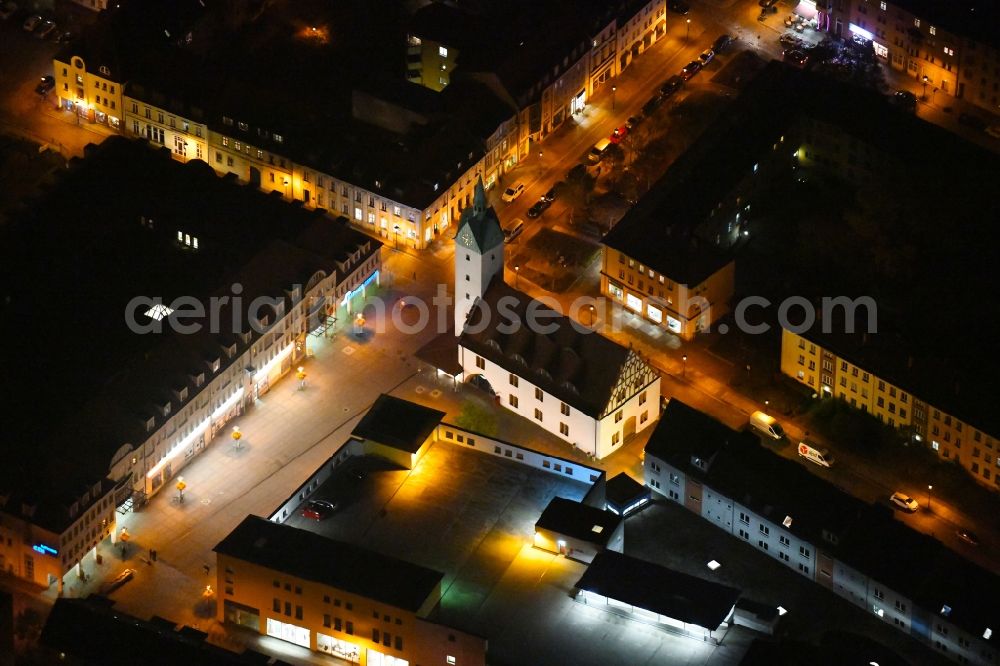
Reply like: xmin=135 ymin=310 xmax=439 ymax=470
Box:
xmin=455 ymin=176 xmax=503 ymax=335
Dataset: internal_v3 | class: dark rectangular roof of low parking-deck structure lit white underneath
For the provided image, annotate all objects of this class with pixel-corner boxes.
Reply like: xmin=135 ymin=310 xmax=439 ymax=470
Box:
xmin=576 ymin=550 xmax=740 ymax=631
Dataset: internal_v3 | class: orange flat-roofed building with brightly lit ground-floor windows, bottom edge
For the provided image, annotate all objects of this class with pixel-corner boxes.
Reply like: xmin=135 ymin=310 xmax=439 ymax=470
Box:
xmin=214 ymin=516 xmax=486 ymax=666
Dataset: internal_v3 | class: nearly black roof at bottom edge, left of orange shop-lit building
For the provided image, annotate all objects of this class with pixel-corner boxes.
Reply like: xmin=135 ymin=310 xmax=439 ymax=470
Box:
xmin=39 ymin=596 xmax=256 ymax=666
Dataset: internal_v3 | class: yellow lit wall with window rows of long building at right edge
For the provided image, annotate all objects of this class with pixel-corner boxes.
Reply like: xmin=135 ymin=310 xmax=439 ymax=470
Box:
xmin=781 ymin=329 xmax=1000 ymax=490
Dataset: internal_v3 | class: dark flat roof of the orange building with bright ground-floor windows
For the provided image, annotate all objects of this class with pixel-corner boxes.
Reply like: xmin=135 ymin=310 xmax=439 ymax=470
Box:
xmin=214 ymin=516 xmax=444 ymax=612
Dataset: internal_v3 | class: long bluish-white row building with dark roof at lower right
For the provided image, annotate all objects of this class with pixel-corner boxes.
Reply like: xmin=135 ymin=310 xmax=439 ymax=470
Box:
xmin=643 ymin=398 xmax=1000 ymax=664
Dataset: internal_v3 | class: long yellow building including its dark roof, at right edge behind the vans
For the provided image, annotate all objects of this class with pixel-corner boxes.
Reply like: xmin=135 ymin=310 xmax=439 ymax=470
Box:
xmin=781 ymin=328 xmax=1000 ymax=490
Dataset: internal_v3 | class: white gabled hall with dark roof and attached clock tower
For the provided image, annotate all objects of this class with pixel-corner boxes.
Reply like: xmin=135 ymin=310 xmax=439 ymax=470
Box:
xmin=455 ymin=181 xmax=660 ymax=458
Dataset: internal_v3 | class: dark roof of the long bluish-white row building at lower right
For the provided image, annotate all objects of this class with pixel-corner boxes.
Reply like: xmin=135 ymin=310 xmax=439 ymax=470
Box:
xmin=646 ymin=398 xmax=1000 ymax=642
